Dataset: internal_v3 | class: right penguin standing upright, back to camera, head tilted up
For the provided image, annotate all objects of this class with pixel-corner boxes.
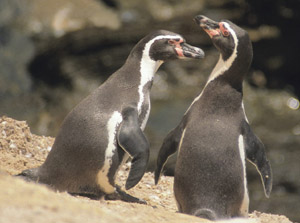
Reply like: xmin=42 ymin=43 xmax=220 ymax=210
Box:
xmin=155 ymin=15 xmax=272 ymax=220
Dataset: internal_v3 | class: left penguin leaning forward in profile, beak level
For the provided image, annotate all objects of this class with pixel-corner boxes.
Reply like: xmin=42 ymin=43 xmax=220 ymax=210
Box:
xmin=18 ymin=30 xmax=204 ymax=203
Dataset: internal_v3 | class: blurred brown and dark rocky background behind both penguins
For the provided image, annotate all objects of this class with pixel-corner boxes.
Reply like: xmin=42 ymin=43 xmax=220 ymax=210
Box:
xmin=0 ymin=0 xmax=300 ymax=222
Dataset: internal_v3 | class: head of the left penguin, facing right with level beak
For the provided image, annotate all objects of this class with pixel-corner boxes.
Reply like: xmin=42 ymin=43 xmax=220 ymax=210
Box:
xmin=134 ymin=30 xmax=204 ymax=62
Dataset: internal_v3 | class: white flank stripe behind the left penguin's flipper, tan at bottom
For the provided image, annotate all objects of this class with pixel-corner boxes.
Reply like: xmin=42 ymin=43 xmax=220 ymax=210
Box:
xmin=97 ymin=111 xmax=123 ymax=194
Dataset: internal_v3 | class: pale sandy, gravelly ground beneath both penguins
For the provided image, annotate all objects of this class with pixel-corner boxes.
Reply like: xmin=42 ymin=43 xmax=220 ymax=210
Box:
xmin=0 ymin=117 xmax=291 ymax=223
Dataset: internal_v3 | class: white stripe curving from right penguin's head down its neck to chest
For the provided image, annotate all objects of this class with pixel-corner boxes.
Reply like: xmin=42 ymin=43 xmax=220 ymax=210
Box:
xmin=185 ymin=22 xmax=239 ymax=114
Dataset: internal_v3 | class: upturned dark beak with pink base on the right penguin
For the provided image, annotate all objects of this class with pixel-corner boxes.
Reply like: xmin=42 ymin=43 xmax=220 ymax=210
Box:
xmin=194 ymin=15 xmax=222 ymax=38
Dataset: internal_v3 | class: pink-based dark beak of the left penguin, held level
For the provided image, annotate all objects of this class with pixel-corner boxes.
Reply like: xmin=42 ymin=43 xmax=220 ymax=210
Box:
xmin=175 ymin=42 xmax=205 ymax=59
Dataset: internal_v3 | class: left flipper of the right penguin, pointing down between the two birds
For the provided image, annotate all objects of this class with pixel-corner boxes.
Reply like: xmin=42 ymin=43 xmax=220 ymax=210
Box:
xmin=154 ymin=123 xmax=183 ymax=184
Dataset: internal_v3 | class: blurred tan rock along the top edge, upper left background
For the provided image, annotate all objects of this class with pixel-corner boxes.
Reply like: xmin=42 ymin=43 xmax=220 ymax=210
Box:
xmin=21 ymin=0 xmax=120 ymax=37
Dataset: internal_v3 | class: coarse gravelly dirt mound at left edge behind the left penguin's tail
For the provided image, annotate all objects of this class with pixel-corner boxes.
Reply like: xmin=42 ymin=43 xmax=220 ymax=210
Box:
xmin=0 ymin=116 xmax=54 ymax=174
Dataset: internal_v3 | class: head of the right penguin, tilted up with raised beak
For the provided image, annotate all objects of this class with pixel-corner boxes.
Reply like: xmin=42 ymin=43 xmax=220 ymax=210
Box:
xmin=194 ymin=15 xmax=252 ymax=61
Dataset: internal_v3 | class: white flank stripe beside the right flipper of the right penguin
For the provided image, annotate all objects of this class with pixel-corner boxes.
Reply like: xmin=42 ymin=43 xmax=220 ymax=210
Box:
xmin=238 ymin=135 xmax=249 ymax=216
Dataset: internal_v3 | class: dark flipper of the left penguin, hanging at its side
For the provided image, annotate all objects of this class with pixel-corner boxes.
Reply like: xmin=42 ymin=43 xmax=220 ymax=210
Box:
xmin=117 ymin=106 xmax=149 ymax=190
